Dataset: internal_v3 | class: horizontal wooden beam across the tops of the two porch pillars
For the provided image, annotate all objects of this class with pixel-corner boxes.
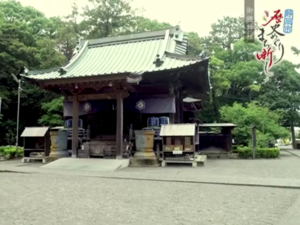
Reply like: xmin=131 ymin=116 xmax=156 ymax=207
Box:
xmin=68 ymin=92 xmax=129 ymax=102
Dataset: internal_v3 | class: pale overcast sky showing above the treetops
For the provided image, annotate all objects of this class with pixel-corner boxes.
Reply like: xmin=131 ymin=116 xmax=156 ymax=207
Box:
xmin=19 ymin=0 xmax=300 ymax=63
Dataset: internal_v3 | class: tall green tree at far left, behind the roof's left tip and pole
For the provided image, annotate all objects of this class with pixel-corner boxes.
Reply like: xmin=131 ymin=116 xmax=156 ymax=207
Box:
xmin=0 ymin=0 xmax=63 ymax=145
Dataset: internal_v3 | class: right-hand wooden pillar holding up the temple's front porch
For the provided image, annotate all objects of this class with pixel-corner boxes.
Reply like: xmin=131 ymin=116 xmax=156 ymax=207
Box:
xmin=116 ymin=93 xmax=123 ymax=158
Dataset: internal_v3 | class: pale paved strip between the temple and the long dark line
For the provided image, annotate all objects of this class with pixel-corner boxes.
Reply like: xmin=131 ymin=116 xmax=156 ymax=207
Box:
xmin=0 ymin=150 xmax=300 ymax=188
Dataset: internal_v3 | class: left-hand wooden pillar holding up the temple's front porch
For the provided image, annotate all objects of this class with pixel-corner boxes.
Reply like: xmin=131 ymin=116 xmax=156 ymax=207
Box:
xmin=72 ymin=96 xmax=79 ymax=158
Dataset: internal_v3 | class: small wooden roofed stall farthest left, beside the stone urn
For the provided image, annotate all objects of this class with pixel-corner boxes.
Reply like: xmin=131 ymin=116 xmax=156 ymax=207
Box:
xmin=21 ymin=127 xmax=51 ymax=162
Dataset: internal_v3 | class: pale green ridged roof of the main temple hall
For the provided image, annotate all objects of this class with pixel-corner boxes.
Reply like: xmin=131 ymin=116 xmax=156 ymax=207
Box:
xmin=26 ymin=27 xmax=207 ymax=80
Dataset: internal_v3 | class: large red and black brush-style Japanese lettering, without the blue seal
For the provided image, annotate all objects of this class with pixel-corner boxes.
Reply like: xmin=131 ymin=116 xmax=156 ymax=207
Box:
xmin=256 ymin=9 xmax=285 ymax=75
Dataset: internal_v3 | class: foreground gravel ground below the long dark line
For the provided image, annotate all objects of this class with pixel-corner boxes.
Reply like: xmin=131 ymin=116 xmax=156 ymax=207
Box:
xmin=0 ymin=173 xmax=300 ymax=225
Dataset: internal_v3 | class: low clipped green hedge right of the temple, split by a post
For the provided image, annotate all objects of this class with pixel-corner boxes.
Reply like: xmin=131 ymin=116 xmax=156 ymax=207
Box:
xmin=236 ymin=147 xmax=280 ymax=159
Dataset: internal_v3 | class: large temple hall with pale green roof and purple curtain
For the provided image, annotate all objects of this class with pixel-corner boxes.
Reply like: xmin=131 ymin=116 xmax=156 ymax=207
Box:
xmin=23 ymin=26 xmax=210 ymax=158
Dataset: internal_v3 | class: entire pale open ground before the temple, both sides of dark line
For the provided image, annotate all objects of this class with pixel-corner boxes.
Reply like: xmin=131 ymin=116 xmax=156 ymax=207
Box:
xmin=0 ymin=149 xmax=300 ymax=225
